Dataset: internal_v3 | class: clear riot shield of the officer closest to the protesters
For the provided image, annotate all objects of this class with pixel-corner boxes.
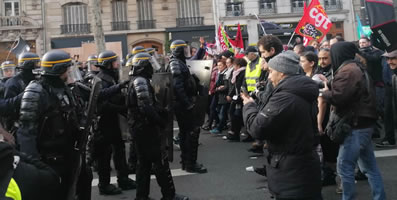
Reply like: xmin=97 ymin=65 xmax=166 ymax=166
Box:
xmin=186 ymin=60 xmax=213 ymax=127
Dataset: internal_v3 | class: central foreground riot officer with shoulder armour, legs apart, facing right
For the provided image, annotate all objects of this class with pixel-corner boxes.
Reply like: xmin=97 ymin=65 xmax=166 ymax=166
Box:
xmin=127 ymin=53 xmax=188 ymax=200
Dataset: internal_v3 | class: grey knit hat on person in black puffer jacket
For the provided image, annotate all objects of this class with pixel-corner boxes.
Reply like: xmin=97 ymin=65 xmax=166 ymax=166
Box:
xmin=268 ymin=51 xmax=301 ymax=75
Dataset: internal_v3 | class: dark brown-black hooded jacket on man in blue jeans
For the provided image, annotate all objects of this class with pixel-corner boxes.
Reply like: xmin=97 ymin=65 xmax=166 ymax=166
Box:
xmin=323 ymin=42 xmax=376 ymax=128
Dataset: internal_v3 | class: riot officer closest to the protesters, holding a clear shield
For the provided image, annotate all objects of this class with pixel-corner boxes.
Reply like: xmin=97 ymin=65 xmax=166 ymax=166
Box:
xmin=169 ymin=40 xmax=207 ymax=173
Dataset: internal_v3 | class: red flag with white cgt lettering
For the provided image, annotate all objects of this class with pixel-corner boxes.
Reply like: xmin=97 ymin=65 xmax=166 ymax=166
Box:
xmin=295 ymin=0 xmax=332 ymax=44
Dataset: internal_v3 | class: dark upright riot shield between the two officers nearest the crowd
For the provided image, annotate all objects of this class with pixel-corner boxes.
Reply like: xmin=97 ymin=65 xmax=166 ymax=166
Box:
xmin=152 ymin=72 xmax=174 ymax=162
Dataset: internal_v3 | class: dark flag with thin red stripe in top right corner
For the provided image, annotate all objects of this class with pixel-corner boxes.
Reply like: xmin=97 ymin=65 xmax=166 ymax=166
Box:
xmin=365 ymin=0 xmax=397 ymax=52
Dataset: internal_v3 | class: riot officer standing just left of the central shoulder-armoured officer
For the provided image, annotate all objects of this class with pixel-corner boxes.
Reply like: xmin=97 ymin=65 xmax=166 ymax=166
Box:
xmin=94 ymin=51 xmax=136 ymax=195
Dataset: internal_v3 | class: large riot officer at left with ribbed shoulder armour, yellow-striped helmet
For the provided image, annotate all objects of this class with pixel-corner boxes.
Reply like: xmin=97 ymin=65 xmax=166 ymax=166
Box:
xmin=17 ymin=50 xmax=87 ymax=199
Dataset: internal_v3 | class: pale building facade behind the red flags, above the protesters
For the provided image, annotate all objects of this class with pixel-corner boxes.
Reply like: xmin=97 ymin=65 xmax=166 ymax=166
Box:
xmin=214 ymin=0 xmax=356 ymax=44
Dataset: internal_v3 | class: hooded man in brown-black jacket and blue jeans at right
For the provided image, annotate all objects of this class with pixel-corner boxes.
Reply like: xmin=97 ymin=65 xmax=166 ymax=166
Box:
xmin=320 ymin=42 xmax=386 ymax=200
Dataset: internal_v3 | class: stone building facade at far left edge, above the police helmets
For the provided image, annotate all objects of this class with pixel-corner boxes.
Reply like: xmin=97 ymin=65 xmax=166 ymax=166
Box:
xmin=0 ymin=0 xmax=44 ymax=62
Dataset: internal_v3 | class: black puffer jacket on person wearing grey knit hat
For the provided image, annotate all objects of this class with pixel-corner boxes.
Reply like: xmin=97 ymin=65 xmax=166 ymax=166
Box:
xmin=243 ymin=75 xmax=321 ymax=199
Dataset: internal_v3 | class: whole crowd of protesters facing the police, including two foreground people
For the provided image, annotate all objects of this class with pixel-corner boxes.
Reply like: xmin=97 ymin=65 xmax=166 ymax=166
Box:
xmin=188 ymin=35 xmax=396 ymax=199
